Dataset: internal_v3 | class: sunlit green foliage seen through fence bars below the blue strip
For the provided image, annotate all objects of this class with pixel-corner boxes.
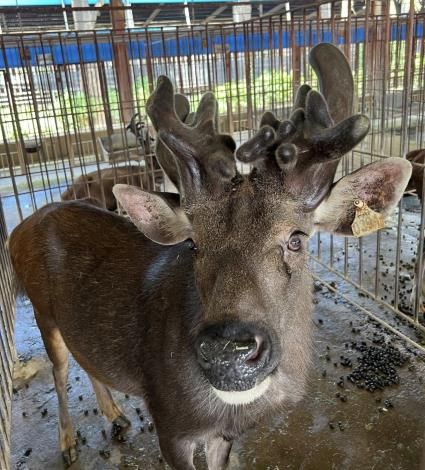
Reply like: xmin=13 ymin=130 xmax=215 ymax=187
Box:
xmin=0 ymin=40 xmax=425 ymax=145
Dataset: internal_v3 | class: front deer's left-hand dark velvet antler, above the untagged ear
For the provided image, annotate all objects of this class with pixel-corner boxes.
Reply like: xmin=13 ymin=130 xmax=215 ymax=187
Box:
xmin=146 ymin=76 xmax=237 ymax=203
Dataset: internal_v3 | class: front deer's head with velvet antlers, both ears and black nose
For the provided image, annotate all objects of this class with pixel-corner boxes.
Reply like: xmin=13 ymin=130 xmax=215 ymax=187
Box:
xmin=114 ymin=45 xmax=411 ymax=406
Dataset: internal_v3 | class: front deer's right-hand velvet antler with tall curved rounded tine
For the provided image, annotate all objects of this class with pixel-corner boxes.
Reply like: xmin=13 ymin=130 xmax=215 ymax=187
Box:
xmin=236 ymin=44 xmax=369 ymax=210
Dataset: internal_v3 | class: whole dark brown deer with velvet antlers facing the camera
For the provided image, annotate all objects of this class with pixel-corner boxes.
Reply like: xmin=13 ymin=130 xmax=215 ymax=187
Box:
xmin=9 ymin=44 xmax=411 ymax=470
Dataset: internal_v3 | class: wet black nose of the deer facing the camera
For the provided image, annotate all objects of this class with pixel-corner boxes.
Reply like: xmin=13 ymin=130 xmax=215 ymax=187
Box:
xmin=196 ymin=322 xmax=276 ymax=391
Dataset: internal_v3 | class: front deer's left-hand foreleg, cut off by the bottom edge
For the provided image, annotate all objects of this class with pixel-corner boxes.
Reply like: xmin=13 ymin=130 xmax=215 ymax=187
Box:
xmin=158 ymin=429 xmax=196 ymax=470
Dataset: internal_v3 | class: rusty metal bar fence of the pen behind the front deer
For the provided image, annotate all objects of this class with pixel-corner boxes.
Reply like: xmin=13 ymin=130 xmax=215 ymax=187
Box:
xmin=0 ymin=1 xmax=425 ymax=462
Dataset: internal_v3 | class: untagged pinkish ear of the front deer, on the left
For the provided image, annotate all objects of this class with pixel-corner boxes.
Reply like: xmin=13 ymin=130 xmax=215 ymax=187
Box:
xmin=112 ymin=184 xmax=192 ymax=245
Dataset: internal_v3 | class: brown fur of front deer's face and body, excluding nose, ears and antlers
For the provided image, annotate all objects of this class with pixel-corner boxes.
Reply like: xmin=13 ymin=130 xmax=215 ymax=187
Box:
xmin=10 ymin=175 xmax=312 ymax=469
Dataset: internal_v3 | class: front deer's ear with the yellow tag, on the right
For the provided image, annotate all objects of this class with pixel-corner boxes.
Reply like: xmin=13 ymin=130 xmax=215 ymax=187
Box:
xmin=314 ymin=158 xmax=412 ymax=236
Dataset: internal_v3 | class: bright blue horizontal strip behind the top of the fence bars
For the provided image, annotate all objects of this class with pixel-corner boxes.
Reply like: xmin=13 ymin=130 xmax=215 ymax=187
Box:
xmin=0 ymin=23 xmax=424 ymax=68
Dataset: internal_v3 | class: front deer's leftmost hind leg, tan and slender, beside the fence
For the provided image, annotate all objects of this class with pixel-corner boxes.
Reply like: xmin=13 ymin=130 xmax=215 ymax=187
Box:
xmin=35 ymin=312 xmax=78 ymax=466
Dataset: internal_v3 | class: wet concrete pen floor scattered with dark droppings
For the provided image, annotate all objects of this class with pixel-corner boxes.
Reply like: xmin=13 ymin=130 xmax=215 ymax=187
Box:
xmin=12 ymin=196 xmax=425 ymax=470
